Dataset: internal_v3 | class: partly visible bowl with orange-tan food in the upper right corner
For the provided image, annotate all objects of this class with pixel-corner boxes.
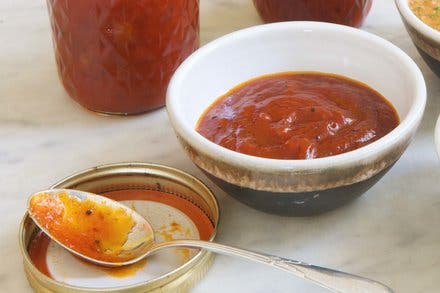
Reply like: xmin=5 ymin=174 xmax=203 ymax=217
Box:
xmin=395 ymin=0 xmax=440 ymax=76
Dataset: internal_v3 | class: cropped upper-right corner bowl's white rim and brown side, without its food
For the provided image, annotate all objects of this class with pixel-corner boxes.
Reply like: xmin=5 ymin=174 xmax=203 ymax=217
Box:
xmin=395 ymin=0 xmax=440 ymax=77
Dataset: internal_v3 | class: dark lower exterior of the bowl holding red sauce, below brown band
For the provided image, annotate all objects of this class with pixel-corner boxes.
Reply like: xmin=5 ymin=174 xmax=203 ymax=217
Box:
xmin=205 ymin=166 xmax=391 ymax=216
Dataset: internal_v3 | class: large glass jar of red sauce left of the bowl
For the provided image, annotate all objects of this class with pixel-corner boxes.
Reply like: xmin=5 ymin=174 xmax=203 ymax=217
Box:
xmin=47 ymin=0 xmax=199 ymax=114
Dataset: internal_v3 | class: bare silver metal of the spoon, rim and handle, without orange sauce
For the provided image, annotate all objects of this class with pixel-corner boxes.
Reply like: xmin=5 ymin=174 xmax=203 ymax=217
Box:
xmin=28 ymin=189 xmax=393 ymax=293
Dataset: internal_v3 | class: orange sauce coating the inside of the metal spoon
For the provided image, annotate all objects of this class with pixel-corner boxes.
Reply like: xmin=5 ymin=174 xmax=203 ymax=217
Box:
xmin=29 ymin=192 xmax=135 ymax=261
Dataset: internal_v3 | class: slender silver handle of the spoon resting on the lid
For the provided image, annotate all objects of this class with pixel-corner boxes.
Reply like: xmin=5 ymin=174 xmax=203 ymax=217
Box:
xmin=150 ymin=240 xmax=393 ymax=293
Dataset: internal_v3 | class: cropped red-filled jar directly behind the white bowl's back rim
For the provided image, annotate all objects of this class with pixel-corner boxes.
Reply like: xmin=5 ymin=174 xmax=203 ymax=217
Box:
xmin=253 ymin=0 xmax=373 ymax=27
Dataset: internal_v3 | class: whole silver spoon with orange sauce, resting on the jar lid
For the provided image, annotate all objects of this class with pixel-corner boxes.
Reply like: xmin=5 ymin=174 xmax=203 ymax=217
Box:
xmin=28 ymin=189 xmax=393 ymax=292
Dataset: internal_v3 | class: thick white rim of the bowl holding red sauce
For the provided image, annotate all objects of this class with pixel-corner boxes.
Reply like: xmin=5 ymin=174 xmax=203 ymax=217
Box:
xmin=166 ymin=21 xmax=427 ymax=175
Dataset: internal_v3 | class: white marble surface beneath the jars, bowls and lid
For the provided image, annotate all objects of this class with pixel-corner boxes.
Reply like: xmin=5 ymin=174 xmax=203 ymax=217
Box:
xmin=0 ymin=0 xmax=440 ymax=292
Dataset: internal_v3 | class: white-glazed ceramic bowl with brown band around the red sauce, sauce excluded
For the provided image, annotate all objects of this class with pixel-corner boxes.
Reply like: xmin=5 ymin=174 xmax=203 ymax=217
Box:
xmin=167 ymin=22 xmax=426 ymax=215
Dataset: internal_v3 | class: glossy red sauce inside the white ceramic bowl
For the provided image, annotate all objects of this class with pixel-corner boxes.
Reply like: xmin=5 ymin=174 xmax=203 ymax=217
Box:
xmin=196 ymin=72 xmax=399 ymax=159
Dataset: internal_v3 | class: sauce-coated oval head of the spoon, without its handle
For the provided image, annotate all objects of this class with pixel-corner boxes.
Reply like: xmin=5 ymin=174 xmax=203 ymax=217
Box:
xmin=28 ymin=189 xmax=154 ymax=266
